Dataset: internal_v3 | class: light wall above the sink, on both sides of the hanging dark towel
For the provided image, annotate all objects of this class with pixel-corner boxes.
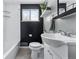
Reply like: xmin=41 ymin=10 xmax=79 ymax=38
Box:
xmin=44 ymin=13 xmax=76 ymax=34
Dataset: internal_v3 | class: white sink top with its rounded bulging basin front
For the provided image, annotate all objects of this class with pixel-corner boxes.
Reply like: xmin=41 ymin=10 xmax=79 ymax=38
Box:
xmin=41 ymin=33 xmax=76 ymax=47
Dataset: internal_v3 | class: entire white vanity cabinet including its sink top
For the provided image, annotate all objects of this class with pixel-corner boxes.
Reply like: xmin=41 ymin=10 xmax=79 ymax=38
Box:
xmin=41 ymin=33 xmax=76 ymax=59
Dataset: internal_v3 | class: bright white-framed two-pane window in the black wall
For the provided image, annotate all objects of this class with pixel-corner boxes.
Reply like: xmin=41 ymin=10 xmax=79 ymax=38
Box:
xmin=22 ymin=9 xmax=39 ymax=21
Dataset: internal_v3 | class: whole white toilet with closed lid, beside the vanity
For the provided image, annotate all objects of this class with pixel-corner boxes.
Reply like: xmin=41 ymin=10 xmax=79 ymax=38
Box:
xmin=29 ymin=42 xmax=43 ymax=59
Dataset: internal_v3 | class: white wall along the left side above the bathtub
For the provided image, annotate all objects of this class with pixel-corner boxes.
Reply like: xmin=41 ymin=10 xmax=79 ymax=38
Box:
xmin=3 ymin=3 xmax=20 ymax=58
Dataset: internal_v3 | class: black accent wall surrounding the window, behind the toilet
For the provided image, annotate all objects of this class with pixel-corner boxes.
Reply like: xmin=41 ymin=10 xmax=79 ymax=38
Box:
xmin=21 ymin=4 xmax=43 ymax=45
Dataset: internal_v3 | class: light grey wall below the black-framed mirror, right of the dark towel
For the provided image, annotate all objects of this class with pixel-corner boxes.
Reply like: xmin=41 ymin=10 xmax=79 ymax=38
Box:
xmin=55 ymin=14 xmax=76 ymax=34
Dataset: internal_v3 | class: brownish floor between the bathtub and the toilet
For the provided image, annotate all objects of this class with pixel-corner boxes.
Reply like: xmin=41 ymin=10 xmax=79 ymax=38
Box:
xmin=16 ymin=48 xmax=31 ymax=59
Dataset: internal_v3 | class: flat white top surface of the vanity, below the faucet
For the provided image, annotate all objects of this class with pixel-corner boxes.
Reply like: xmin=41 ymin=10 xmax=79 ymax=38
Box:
xmin=41 ymin=33 xmax=76 ymax=43
